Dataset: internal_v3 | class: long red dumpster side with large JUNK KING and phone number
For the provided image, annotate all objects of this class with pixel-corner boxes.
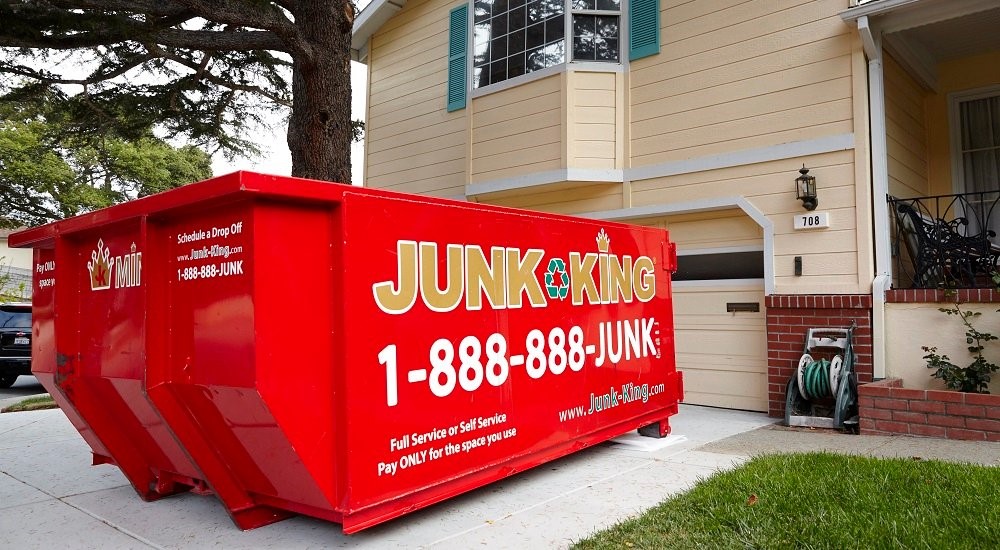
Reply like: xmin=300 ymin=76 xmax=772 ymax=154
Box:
xmin=344 ymin=195 xmax=681 ymax=531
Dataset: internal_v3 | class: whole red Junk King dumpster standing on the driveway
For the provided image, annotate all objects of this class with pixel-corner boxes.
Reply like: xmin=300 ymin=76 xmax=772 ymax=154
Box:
xmin=10 ymin=172 xmax=682 ymax=533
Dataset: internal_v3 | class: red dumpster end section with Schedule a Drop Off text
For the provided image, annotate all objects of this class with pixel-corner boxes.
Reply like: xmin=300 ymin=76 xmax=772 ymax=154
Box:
xmin=149 ymin=200 xmax=335 ymax=528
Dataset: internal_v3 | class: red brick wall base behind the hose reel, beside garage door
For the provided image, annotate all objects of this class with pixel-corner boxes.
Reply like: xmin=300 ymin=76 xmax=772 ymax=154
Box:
xmin=764 ymin=294 xmax=872 ymax=418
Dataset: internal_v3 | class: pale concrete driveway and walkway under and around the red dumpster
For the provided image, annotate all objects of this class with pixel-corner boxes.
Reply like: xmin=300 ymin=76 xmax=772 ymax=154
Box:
xmin=0 ymin=406 xmax=1000 ymax=549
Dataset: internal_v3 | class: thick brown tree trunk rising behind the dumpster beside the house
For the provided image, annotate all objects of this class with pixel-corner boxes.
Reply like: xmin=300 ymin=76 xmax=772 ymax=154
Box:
xmin=288 ymin=0 xmax=354 ymax=184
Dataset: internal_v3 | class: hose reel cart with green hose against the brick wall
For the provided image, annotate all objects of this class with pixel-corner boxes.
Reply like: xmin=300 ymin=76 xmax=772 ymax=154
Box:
xmin=785 ymin=323 xmax=858 ymax=430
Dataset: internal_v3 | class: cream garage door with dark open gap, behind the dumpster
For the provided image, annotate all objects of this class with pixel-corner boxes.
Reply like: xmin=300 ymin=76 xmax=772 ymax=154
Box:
xmin=666 ymin=211 xmax=767 ymax=411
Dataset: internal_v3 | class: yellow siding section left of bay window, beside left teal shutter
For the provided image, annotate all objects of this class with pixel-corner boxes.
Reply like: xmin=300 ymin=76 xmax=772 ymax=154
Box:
xmin=365 ymin=0 xmax=468 ymax=196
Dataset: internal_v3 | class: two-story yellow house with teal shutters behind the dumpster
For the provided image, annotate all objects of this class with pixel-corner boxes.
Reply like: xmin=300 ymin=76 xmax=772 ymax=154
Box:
xmin=352 ymin=0 xmax=1000 ymax=415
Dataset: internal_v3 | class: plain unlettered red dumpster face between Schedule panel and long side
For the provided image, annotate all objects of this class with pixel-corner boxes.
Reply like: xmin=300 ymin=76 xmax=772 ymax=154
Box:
xmin=252 ymin=202 xmax=338 ymax=508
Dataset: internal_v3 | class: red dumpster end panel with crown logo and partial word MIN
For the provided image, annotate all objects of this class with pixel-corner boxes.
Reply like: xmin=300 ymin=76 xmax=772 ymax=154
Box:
xmin=55 ymin=223 xmax=201 ymax=499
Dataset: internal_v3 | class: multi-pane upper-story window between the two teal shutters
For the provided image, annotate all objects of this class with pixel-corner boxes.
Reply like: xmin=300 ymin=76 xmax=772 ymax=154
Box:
xmin=472 ymin=0 xmax=621 ymax=88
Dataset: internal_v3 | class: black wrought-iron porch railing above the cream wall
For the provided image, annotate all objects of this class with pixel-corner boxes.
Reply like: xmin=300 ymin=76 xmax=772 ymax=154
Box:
xmin=889 ymin=192 xmax=1000 ymax=288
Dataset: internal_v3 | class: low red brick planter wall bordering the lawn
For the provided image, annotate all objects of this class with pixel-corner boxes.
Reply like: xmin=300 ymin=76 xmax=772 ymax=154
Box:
xmin=858 ymin=378 xmax=1000 ymax=441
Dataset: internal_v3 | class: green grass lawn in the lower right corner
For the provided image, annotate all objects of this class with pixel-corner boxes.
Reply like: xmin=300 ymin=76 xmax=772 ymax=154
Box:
xmin=574 ymin=453 xmax=1000 ymax=549
